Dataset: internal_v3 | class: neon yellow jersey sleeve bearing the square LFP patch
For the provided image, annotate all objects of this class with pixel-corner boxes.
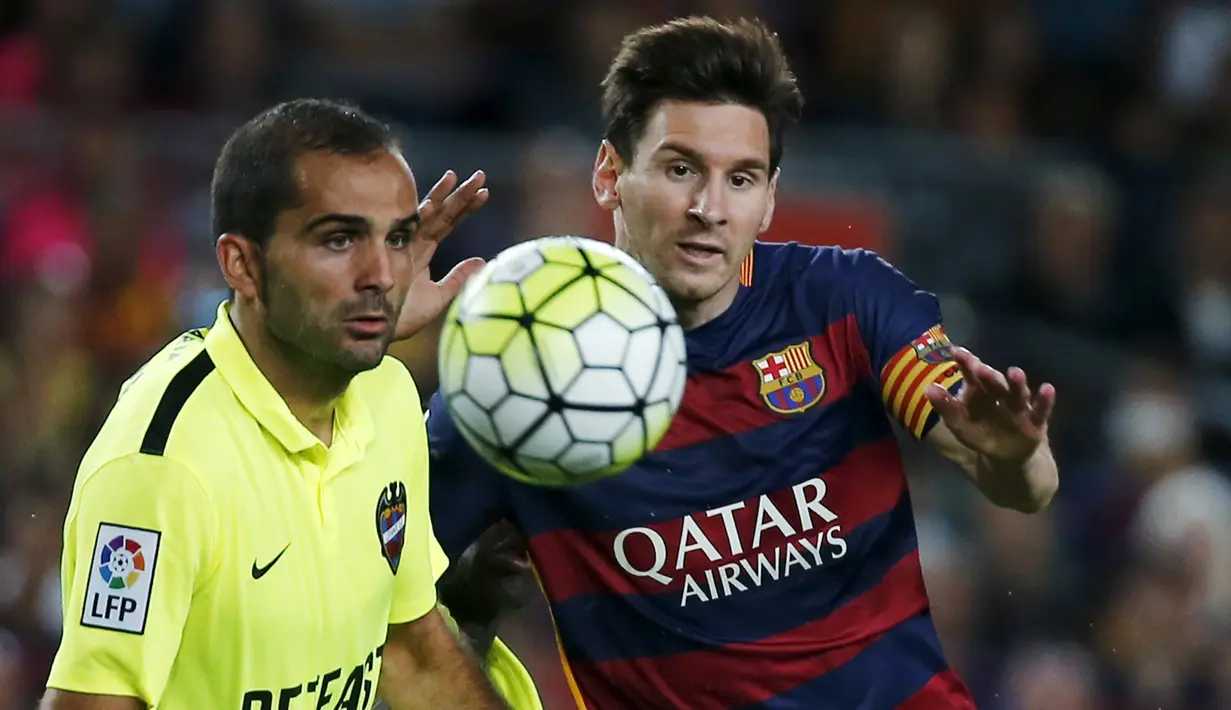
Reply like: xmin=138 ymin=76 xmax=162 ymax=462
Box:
xmin=47 ymin=454 xmax=218 ymax=706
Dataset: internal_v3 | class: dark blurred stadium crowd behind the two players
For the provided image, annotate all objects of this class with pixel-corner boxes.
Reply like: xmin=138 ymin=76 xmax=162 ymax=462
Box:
xmin=0 ymin=0 xmax=1231 ymax=710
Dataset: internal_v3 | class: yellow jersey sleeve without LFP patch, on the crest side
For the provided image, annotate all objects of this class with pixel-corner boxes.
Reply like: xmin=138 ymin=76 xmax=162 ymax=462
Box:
xmin=389 ymin=406 xmax=447 ymax=624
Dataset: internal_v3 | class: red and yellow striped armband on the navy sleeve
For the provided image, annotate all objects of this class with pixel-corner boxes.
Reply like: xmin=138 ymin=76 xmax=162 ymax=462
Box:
xmin=880 ymin=325 xmax=961 ymax=439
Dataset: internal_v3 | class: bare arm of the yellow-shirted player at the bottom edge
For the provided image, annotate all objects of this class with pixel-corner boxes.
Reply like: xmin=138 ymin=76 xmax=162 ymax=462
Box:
xmin=379 ymin=610 xmax=507 ymax=710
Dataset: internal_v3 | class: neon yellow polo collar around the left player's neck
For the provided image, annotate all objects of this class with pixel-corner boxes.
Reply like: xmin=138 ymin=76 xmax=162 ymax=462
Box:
xmin=206 ymin=301 xmax=374 ymax=455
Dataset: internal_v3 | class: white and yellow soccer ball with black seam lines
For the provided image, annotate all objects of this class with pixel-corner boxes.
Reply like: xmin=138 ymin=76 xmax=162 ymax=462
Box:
xmin=439 ymin=236 xmax=687 ymax=486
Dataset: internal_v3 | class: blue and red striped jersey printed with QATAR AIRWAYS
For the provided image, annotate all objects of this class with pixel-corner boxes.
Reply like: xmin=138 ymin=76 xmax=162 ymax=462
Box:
xmin=428 ymin=244 xmax=974 ymax=710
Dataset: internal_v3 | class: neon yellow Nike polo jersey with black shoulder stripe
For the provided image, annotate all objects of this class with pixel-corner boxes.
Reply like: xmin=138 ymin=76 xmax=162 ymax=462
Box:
xmin=48 ymin=304 xmax=439 ymax=710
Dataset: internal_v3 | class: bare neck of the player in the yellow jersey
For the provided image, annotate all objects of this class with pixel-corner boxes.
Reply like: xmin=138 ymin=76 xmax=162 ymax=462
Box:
xmin=230 ymin=303 xmax=351 ymax=445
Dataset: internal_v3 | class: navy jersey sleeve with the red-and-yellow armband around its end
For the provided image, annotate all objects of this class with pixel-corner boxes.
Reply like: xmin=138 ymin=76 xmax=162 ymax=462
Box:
xmin=851 ymin=251 xmax=961 ymax=439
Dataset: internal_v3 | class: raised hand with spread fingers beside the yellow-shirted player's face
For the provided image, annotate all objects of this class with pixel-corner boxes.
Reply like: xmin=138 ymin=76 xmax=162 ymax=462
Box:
xmin=394 ymin=170 xmax=489 ymax=340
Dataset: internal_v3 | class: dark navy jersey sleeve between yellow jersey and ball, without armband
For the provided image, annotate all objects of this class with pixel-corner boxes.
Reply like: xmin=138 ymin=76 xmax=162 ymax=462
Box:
xmin=425 ymin=393 xmax=508 ymax=560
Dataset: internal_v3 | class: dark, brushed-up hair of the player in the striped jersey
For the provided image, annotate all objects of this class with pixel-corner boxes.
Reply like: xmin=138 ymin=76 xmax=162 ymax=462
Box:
xmin=602 ymin=17 xmax=804 ymax=167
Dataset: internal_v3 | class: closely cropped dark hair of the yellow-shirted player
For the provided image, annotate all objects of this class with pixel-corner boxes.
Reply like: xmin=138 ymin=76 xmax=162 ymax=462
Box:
xmin=211 ymin=98 xmax=399 ymax=247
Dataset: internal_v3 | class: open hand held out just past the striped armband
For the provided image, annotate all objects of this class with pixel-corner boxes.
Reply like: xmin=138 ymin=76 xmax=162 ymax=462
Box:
xmin=927 ymin=348 xmax=1056 ymax=464
